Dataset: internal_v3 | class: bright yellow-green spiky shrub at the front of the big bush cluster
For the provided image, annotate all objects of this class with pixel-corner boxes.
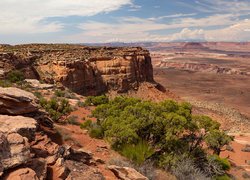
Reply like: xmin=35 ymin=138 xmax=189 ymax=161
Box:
xmin=120 ymin=141 xmax=154 ymax=165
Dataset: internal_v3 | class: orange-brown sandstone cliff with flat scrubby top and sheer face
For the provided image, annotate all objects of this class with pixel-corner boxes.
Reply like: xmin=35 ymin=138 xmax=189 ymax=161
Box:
xmin=0 ymin=44 xmax=153 ymax=95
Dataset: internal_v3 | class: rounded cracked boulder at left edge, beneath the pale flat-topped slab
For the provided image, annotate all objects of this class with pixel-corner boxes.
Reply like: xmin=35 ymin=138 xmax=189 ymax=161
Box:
xmin=0 ymin=132 xmax=31 ymax=170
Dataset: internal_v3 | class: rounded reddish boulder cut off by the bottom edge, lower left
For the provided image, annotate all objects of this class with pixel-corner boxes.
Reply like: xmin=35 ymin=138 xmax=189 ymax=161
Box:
xmin=3 ymin=168 xmax=39 ymax=180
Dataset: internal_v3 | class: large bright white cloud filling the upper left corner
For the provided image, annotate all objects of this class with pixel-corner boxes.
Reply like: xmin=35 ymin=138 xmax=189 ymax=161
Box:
xmin=0 ymin=0 xmax=132 ymax=34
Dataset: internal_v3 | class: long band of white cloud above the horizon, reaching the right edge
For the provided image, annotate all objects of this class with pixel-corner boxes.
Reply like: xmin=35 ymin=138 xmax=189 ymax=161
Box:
xmin=67 ymin=15 xmax=250 ymax=42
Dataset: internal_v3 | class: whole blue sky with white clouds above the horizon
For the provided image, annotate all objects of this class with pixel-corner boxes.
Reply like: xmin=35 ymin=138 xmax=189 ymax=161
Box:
xmin=0 ymin=0 xmax=250 ymax=44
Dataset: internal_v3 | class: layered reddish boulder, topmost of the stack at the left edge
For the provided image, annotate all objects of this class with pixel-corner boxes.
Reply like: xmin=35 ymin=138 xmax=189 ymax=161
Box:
xmin=0 ymin=87 xmax=38 ymax=115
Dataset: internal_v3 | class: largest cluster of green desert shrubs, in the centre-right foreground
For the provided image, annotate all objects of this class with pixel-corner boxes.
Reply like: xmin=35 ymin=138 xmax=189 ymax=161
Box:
xmin=86 ymin=97 xmax=233 ymax=179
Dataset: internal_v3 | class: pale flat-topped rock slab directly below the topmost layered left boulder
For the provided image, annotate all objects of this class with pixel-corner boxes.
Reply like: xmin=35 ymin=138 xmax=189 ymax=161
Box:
xmin=0 ymin=115 xmax=37 ymax=140
